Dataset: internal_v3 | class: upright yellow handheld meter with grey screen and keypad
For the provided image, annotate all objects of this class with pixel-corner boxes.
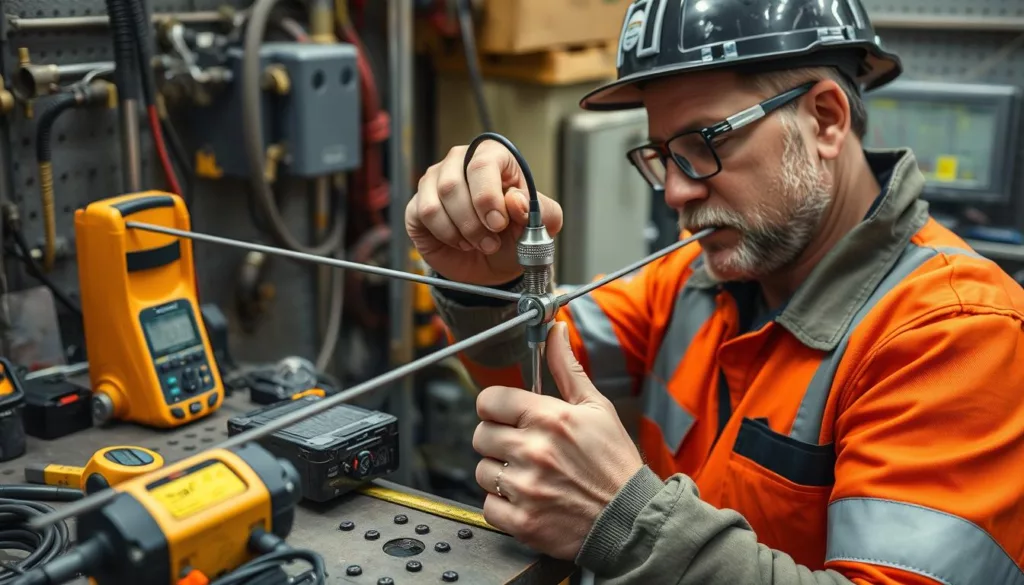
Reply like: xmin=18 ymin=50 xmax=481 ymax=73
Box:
xmin=75 ymin=191 xmax=224 ymax=428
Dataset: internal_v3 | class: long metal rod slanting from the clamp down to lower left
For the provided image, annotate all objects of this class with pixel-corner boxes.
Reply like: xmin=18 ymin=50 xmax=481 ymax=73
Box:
xmin=28 ymin=309 xmax=537 ymax=530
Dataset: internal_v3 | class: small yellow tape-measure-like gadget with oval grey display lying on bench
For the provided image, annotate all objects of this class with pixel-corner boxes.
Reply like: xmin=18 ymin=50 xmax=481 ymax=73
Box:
xmin=25 ymin=446 xmax=164 ymax=494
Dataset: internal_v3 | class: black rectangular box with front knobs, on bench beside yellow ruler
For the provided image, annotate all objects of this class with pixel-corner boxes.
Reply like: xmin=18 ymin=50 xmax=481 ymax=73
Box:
xmin=227 ymin=396 xmax=399 ymax=502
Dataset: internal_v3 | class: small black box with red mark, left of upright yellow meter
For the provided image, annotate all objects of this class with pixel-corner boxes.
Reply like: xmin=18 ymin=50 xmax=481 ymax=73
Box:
xmin=24 ymin=376 xmax=92 ymax=441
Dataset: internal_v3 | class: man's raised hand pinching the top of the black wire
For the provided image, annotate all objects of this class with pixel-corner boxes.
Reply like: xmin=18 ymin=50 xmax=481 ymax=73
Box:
xmin=406 ymin=140 xmax=562 ymax=286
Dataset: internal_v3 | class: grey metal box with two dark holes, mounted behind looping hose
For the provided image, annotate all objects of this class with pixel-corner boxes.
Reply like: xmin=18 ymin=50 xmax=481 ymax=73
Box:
xmin=193 ymin=43 xmax=362 ymax=178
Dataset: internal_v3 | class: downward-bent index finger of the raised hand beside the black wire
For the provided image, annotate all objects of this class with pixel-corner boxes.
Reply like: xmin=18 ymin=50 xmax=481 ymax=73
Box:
xmin=465 ymin=141 xmax=523 ymax=233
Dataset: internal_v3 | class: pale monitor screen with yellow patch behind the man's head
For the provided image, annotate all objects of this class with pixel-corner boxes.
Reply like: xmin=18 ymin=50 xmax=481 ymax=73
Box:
xmin=864 ymin=97 xmax=997 ymax=191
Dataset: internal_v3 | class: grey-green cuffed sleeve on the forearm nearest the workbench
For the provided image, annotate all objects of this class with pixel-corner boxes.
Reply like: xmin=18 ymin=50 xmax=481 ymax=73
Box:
xmin=577 ymin=466 xmax=853 ymax=585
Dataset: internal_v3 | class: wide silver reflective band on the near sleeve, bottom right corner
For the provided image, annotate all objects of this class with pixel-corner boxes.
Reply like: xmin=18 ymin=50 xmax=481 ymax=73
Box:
xmin=825 ymin=498 xmax=1024 ymax=585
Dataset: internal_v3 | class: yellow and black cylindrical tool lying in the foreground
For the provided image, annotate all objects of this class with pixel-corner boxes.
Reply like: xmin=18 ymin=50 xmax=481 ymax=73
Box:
xmin=18 ymin=444 xmax=307 ymax=585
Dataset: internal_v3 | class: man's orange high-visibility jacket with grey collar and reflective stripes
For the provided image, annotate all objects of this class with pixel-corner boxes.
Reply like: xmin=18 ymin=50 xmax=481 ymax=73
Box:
xmin=434 ymin=151 xmax=1024 ymax=585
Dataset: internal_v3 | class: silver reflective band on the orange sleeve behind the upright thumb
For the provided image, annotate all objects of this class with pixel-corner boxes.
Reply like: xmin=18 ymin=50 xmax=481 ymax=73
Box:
xmin=566 ymin=294 xmax=633 ymax=400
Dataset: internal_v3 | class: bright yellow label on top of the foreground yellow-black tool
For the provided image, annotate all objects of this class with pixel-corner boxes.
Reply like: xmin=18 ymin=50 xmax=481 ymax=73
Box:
xmin=150 ymin=461 xmax=246 ymax=519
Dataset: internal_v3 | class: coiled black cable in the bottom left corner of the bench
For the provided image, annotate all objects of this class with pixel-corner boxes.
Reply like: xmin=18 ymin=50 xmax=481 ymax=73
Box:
xmin=0 ymin=493 xmax=75 ymax=585
